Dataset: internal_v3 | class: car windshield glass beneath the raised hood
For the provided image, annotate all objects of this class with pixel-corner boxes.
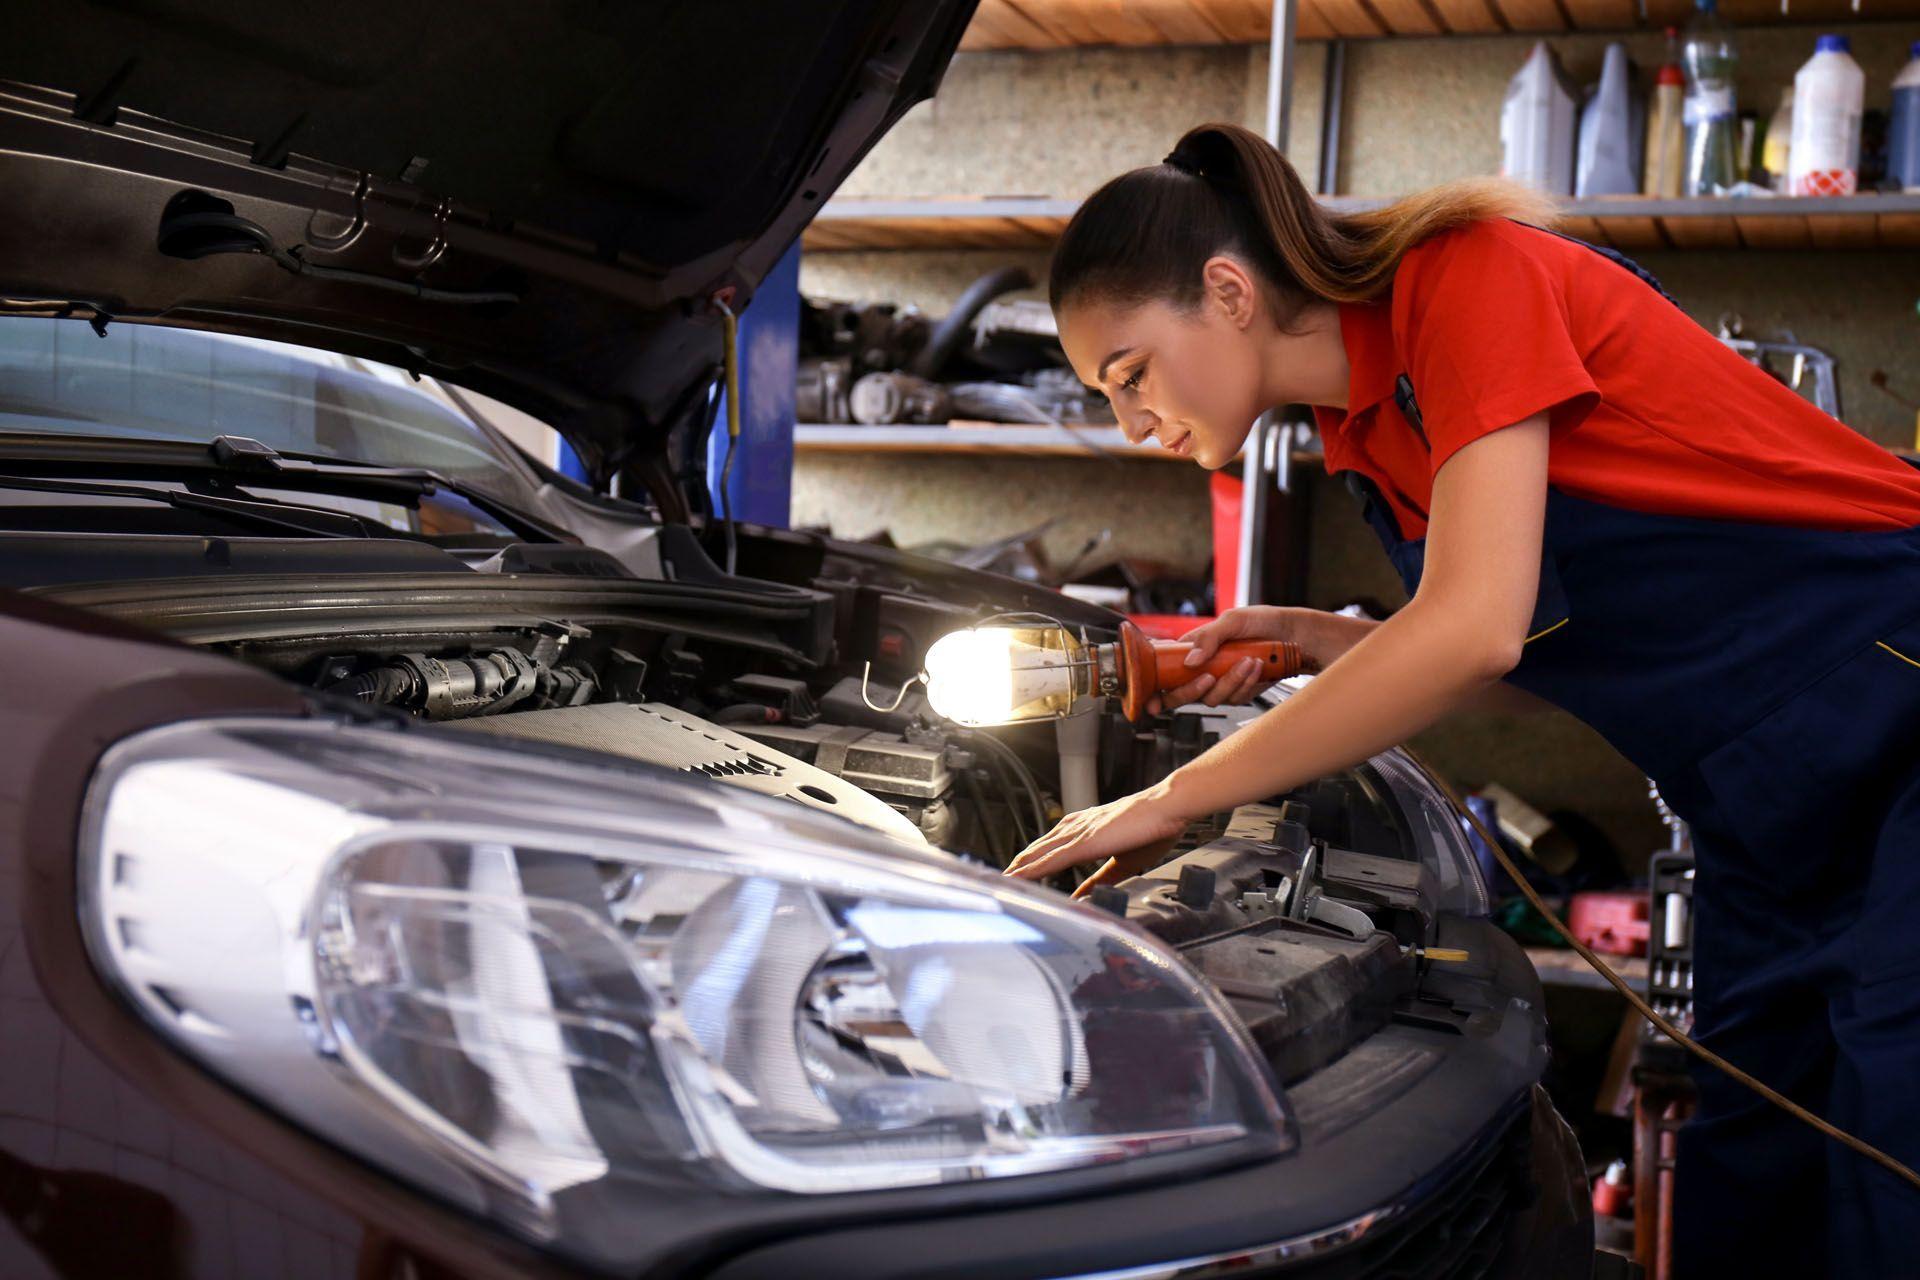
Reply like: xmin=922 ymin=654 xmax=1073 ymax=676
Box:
xmin=0 ymin=317 xmax=528 ymax=505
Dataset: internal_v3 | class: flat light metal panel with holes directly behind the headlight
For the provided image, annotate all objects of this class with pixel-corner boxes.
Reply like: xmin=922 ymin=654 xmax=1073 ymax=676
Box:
xmin=451 ymin=702 xmax=924 ymax=844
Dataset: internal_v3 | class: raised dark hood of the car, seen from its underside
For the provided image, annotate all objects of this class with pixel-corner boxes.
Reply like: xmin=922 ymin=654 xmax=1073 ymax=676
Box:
xmin=0 ymin=0 xmax=975 ymax=476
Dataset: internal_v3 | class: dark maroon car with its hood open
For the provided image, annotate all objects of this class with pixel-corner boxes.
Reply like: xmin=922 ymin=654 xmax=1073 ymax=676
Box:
xmin=0 ymin=0 xmax=1594 ymax=1280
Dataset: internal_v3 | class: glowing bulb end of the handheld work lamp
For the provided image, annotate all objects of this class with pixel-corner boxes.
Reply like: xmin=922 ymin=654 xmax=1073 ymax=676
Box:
xmin=927 ymin=628 xmax=1085 ymax=725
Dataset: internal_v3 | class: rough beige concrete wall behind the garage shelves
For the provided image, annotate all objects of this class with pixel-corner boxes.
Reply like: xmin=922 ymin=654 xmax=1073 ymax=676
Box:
xmin=793 ymin=23 xmax=1920 ymax=871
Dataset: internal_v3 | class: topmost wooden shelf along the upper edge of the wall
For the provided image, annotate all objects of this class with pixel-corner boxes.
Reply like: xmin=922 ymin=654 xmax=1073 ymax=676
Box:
xmin=960 ymin=0 xmax=1920 ymax=50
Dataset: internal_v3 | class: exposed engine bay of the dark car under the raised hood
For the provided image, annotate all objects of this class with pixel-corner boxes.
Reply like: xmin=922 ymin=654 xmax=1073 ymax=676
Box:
xmin=36 ymin=530 xmax=1484 ymax=1082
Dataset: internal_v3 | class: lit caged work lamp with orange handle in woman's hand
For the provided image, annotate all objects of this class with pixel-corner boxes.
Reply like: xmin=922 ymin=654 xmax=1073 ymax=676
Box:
xmin=924 ymin=614 xmax=1304 ymax=725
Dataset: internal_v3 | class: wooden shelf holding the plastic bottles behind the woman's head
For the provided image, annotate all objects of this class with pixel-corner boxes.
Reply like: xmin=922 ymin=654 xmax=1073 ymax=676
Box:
xmin=803 ymin=194 xmax=1920 ymax=253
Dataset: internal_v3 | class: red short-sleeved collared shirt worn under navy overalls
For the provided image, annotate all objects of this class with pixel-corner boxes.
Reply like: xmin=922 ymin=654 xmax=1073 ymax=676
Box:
xmin=1315 ymin=221 xmax=1920 ymax=537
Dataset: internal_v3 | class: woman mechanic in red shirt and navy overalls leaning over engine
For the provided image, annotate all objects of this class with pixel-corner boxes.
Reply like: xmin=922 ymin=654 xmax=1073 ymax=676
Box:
xmin=1010 ymin=125 xmax=1920 ymax=1276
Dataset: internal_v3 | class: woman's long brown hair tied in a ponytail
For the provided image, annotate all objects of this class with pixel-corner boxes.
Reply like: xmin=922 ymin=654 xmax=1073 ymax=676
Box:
xmin=1048 ymin=125 xmax=1555 ymax=326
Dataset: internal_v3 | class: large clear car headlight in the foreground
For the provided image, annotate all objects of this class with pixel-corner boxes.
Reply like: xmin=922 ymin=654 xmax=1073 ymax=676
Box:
xmin=81 ymin=720 xmax=1288 ymax=1261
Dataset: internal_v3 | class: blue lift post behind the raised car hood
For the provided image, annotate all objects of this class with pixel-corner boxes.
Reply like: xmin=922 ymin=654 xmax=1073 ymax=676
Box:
xmin=707 ymin=244 xmax=801 ymax=528
